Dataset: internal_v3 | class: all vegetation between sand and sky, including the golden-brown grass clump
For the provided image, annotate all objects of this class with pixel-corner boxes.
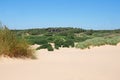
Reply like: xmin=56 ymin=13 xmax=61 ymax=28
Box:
xmin=0 ymin=20 xmax=120 ymax=58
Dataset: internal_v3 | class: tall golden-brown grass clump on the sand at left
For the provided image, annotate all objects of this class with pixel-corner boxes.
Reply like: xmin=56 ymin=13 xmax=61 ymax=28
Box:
xmin=0 ymin=27 xmax=35 ymax=58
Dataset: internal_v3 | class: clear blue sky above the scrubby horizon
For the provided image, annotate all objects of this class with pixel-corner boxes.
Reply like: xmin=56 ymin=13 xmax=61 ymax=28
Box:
xmin=0 ymin=0 xmax=120 ymax=29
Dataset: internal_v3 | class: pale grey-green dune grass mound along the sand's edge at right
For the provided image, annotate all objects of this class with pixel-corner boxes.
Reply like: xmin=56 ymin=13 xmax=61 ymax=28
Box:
xmin=76 ymin=36 xmax=120 ymax=49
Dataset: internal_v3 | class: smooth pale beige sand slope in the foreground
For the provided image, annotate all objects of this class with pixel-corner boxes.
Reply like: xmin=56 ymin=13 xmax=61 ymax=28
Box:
xmin=0 ymin=45 xmax=120 ymax=80
